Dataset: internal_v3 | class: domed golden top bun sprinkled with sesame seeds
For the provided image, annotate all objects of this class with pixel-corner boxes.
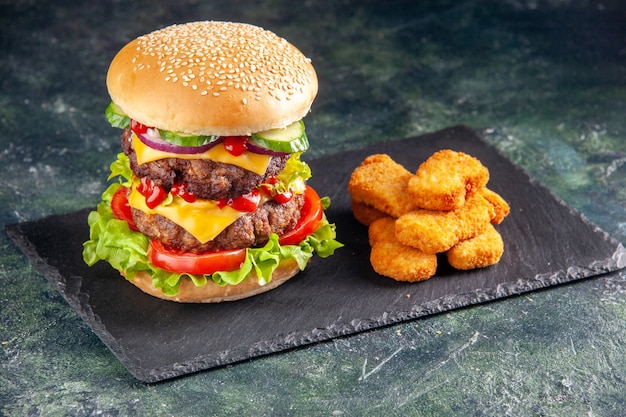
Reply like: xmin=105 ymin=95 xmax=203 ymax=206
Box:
xmin=107 ymin=22 xmax=317 ymax=136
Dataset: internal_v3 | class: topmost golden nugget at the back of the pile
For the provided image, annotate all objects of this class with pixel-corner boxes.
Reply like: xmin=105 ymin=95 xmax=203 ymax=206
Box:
xmin=407 ymin=149 xmax=489 ymax=210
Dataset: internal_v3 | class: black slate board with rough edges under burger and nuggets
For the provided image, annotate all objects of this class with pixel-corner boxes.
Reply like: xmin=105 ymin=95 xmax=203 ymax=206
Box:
xmin=7 ymin=126 xmax=626 ymax=382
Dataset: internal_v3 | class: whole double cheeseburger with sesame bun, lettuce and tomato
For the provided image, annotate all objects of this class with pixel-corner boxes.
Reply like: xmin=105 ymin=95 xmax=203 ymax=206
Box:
xmin=83 ymin=22 xmax=341 ymax=302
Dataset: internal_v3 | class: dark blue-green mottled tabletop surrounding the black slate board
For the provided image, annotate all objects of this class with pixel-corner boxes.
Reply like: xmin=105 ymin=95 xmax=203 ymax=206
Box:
xmin=0 ymin=0 xmax=626 ymax=416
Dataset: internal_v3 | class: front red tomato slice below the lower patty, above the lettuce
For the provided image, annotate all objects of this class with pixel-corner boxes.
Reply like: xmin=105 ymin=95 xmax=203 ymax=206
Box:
xmin=148 ymin=240 xmax=246 ymax=275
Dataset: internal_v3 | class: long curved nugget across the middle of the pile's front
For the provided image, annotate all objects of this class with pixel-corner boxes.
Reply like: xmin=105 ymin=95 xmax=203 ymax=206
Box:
xmin=395 ymin=193 xmax=494 ymax=254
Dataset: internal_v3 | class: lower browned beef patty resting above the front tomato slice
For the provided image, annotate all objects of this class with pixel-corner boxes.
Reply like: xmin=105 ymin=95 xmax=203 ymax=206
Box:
xmin=132 ymin=195 xmax=304 ymax=252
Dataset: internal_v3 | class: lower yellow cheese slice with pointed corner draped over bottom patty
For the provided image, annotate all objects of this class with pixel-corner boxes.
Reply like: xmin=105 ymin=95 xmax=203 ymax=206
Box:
xmin=128 ymin=185 xmax=245 ymax=243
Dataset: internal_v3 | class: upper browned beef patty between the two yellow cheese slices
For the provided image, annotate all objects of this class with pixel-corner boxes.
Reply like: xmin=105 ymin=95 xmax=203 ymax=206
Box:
xmin=122 ymin=129 xmax=289 ymax=200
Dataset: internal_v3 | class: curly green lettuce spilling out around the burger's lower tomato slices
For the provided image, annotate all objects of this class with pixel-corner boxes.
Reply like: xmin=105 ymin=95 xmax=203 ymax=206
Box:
xmin=83 ymin=154 xmax=343 ymax=296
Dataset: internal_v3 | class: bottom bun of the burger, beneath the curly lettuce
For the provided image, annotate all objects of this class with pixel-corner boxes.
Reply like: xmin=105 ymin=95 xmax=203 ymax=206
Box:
xmin=124 ymin=259 xmax=300 ymax=303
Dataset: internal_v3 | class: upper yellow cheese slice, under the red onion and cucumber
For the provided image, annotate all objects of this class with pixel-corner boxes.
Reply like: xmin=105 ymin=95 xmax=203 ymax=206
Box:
xmin=132 ymin=133 xmax=272 ymax=175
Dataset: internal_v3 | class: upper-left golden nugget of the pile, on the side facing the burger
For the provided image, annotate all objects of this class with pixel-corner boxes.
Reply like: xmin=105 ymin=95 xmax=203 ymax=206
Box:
xmin=348 ymin=154 xmax=413 ymax=217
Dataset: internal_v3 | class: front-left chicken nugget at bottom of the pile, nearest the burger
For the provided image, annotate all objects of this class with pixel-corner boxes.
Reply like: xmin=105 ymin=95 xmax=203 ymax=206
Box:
xmin=370 ymin=242 xmax=437 ymax=282
